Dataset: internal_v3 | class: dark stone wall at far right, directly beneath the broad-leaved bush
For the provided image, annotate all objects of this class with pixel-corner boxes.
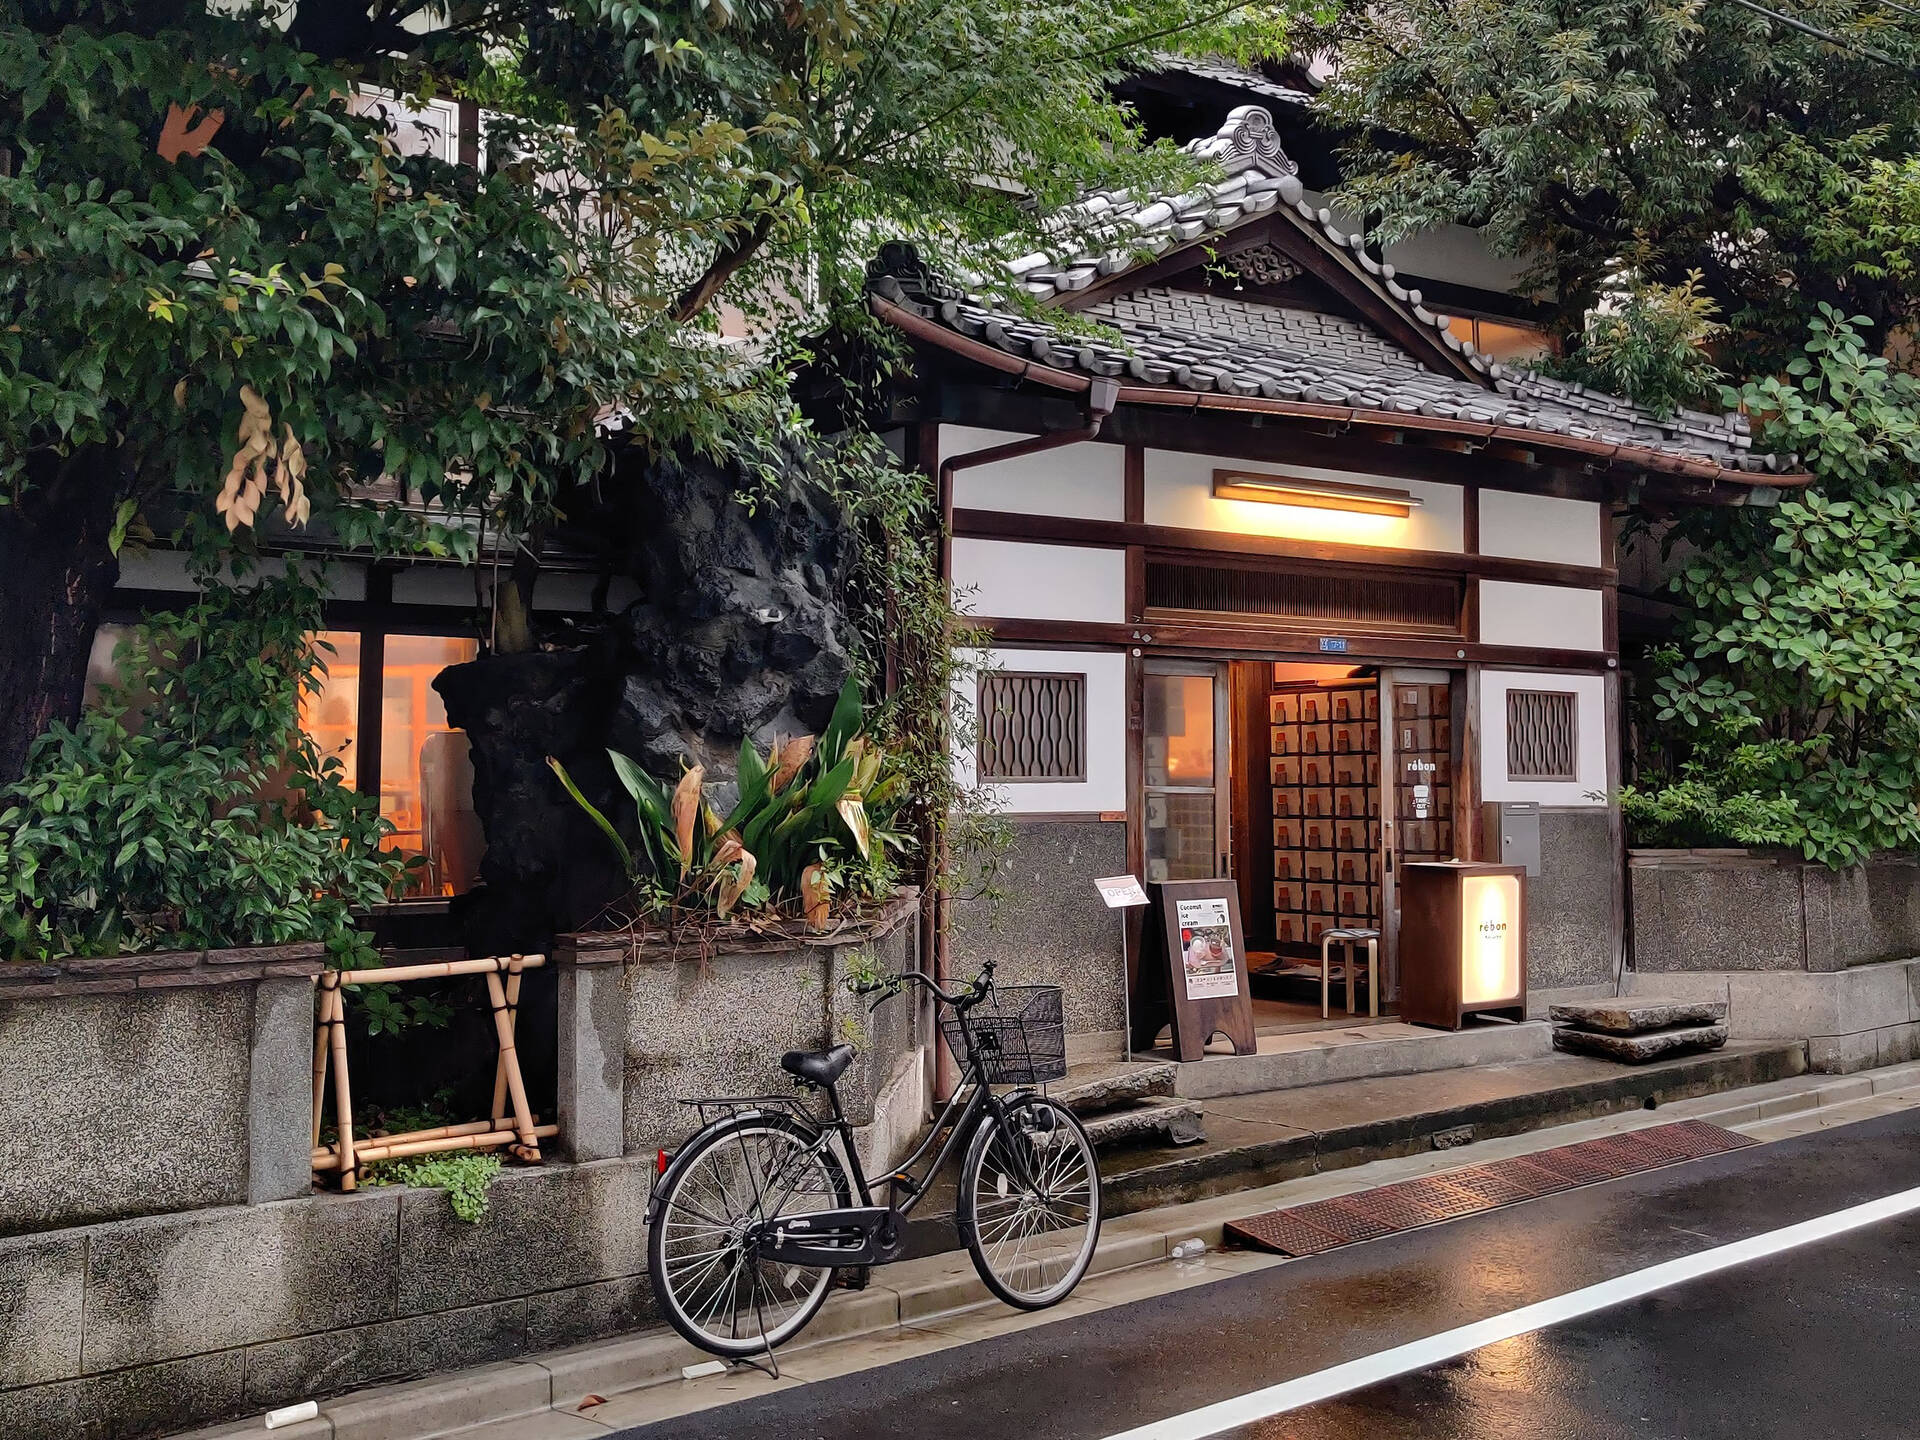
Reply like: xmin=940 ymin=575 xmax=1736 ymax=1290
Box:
xmin=1628 ymin=851 xmax=1920 ymax=975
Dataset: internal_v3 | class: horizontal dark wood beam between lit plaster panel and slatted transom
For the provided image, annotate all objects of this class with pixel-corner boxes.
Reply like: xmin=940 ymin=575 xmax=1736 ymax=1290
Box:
xmin=954 ymin=511 xmax=1619 ymax=589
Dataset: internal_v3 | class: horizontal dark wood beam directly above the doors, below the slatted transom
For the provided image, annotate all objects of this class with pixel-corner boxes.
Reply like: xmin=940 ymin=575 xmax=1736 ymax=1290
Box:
xmin=968 ymin=616 xmax=1615 ymax=674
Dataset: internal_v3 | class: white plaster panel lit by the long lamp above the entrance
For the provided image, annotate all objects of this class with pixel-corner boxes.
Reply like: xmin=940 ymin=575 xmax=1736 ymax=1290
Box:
xmin=1146 ymin=449 xmax=1465 ymax=553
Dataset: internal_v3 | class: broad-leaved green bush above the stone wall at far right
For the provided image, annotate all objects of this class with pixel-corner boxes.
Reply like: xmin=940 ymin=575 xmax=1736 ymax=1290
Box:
xmin=1630 ymin=307 xmax=1920 ymax=866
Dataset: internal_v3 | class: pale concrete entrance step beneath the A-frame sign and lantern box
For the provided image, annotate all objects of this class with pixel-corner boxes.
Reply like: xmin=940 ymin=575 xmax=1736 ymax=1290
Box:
xmin=1173 ymin=1020 xmax=1553 ymax=1100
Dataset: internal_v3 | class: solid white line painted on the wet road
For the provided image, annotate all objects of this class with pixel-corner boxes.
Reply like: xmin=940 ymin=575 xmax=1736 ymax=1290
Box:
xmin=1108 ymin=1188 xmax=1920 ymax=1440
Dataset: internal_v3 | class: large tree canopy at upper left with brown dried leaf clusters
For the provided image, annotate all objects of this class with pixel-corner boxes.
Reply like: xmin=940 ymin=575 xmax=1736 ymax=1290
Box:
xmin=0 ymin=0 xmax=1288 ymax=780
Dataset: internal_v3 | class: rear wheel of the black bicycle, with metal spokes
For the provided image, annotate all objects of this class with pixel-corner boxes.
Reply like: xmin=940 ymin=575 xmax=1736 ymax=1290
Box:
xmin=647 ymin=1114 xmax=851 ymax=1359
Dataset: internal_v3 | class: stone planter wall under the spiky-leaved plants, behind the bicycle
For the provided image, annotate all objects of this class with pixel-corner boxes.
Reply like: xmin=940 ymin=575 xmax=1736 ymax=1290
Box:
xmin=555 ymin=891 xmax=924 ymax=1160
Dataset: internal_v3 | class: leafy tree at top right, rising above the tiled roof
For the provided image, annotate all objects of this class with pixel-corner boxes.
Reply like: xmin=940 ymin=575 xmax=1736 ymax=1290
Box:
xmin=1317 ymin=0 xmax=1920 ymax=349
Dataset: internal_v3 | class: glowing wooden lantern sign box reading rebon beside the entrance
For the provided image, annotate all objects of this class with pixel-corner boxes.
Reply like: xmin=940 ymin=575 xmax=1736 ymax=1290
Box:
xmin=1400 ymin=860 xmax=1526 ymax=1029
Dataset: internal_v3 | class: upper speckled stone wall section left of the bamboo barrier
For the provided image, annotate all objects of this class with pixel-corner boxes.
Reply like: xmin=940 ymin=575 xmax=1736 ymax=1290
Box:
xmin=0 ymin=945 xmax=326 ymax=1235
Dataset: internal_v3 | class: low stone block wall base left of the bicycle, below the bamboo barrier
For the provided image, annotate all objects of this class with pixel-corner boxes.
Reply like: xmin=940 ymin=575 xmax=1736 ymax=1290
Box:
xmin=0 ymin=1159 xmax=655 ymax=1440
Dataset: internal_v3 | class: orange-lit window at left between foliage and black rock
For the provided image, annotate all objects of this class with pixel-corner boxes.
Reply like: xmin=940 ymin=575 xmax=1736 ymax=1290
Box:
xmin=301 ymin=630 xmax=486 ymax=895
